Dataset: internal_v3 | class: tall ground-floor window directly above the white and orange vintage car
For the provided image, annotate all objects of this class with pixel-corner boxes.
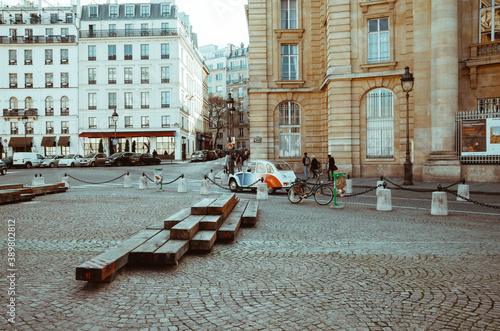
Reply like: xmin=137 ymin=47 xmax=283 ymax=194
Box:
xmin=279 ymin=102 xmax=300 ymax=158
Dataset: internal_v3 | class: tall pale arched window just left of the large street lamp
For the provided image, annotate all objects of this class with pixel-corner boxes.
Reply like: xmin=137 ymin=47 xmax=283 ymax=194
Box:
xmin=366 ymin=89 xmax=394 ymax=158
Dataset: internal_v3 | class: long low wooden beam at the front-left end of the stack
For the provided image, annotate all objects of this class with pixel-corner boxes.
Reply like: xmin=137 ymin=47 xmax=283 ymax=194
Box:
xmin=76 ymin=230 xmax=159 ymax=282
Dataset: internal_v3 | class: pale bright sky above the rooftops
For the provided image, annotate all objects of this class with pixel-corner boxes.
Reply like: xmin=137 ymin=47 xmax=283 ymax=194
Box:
xmin=0 ymin=0 xmax=248 ymax=47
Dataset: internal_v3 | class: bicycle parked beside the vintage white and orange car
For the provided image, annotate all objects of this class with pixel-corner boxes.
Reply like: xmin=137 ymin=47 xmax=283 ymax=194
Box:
xmin=288 ymin=177 xmax=333 ymax=205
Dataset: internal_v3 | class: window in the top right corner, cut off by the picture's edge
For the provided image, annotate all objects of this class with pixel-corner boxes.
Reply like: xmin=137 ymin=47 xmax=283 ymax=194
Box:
xmin=479 ymin=0 xmax=500 ymax=43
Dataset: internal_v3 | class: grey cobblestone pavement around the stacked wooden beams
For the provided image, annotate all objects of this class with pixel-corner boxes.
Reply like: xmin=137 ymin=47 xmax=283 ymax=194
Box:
xmin=0 ymin=186 xmax=500 ymax=330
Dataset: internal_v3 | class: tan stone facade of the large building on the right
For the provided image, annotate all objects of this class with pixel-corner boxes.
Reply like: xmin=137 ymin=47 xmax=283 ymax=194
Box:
xmin=247 ymin=0 xmax=500 ymax=181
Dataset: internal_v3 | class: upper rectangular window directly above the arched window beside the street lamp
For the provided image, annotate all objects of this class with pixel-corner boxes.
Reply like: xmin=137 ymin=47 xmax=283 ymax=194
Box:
xmin=368 ymin=18 xmax=390 ymax=63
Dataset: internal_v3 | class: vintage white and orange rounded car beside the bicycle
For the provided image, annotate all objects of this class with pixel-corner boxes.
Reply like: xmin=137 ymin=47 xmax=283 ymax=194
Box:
xmin=229 ymin=160 xmax=297 ymax=194
